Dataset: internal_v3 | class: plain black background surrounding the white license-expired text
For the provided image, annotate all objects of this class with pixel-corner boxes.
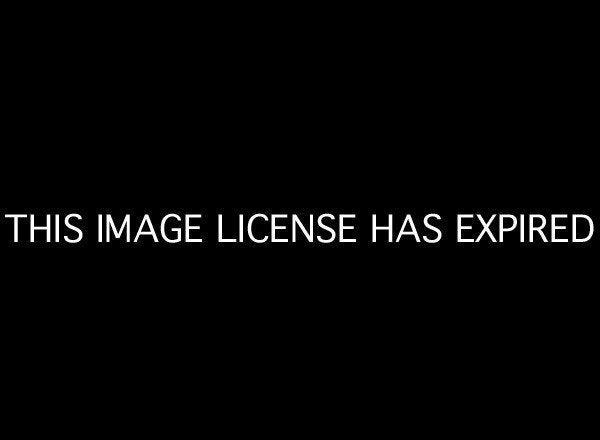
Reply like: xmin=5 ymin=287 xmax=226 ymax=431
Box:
xmin=1 ymin=5 xmax=598 ymax=433
